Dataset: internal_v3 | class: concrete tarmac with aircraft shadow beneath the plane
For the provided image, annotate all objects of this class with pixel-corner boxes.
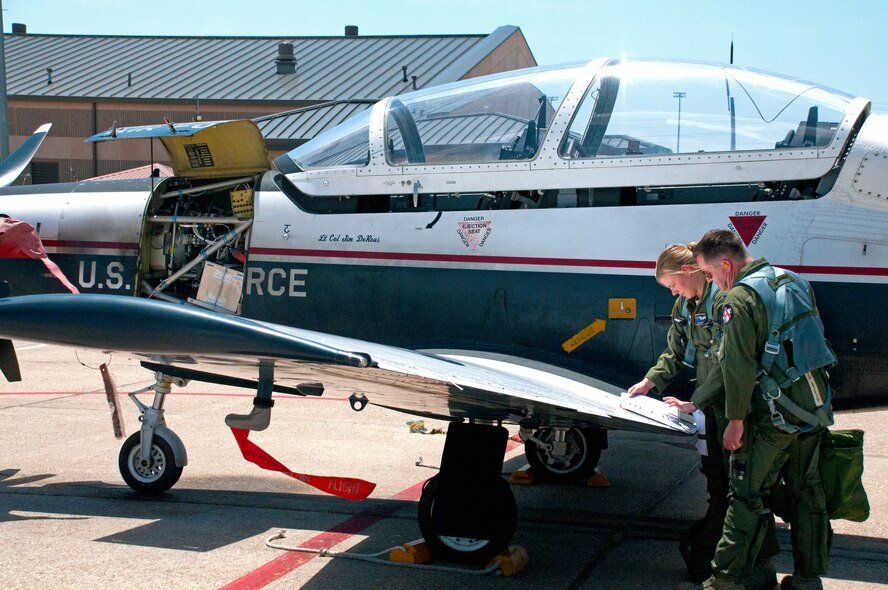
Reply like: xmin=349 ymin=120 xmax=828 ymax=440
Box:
xmin=0 ymin=342 xmax=888 ymax=590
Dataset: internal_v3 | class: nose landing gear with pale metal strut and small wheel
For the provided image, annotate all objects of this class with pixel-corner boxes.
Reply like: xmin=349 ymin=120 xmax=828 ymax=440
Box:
xmin=117 ymin=373 xmax=188 ymax=495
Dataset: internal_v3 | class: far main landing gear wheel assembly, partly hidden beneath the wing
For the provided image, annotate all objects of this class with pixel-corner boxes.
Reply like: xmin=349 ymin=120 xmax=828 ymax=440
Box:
xmin=519 ymin=426 xmax=607 ymax=482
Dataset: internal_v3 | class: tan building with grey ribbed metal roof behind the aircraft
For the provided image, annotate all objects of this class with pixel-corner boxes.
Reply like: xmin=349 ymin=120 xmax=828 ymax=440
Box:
xmin=4 ymin=26 xmax=536 ymax=181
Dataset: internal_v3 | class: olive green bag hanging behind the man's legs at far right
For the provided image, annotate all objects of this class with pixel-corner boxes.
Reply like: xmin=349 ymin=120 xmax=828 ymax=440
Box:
xmin=820 ymin=430 xmax=870 ymax=522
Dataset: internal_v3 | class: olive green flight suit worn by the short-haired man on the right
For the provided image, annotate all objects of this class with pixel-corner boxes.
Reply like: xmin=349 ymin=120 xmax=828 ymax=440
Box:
xmin=712 ymin=258 xmax=829 ymax=578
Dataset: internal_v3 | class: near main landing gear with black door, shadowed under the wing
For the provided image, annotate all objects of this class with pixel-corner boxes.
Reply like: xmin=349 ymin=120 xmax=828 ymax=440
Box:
xmin=418 ymin=422 xmax=518 ymax=563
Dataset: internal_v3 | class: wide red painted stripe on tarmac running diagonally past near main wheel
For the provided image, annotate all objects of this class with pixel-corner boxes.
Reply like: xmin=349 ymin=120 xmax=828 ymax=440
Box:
xmin=219 ymin=438 xmax=523 ymax=590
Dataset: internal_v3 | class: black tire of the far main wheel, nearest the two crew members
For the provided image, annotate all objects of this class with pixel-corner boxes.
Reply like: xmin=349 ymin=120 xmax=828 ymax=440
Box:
xmin=524 ymin=427 xmax=601 ymax=482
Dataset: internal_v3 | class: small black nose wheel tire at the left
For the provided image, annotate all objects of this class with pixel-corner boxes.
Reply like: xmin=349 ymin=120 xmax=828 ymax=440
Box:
xmin=117 ymin=432 xmax=182 ymax=495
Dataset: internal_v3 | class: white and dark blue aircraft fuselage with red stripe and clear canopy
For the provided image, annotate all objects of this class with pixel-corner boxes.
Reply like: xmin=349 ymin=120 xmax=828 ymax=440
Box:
xmin=0 ymin=61 xmax=888 ymax=406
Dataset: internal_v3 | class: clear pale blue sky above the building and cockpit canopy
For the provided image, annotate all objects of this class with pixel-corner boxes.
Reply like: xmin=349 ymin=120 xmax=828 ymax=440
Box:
xmin=2 ymin=0 xmax=888 ymax=112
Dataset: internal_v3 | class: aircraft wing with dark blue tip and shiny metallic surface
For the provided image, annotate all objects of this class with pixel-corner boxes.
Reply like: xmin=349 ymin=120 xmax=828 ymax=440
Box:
xmin=0 ymin=294 xmax=690 ymax=433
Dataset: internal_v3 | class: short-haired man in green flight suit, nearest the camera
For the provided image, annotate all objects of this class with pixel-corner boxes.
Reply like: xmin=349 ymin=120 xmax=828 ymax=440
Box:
xmin=694 ymin=230 xmax=829 ymax=590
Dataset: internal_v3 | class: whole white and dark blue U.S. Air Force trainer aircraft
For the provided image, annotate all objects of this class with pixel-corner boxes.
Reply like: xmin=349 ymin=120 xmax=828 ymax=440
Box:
xmin=0 ymin=59 xmax=888 ymax=558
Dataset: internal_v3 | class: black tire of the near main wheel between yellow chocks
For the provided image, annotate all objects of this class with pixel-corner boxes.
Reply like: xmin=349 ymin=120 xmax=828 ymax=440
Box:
xmin=418 ymin=475 xmax=518 ymax=564
